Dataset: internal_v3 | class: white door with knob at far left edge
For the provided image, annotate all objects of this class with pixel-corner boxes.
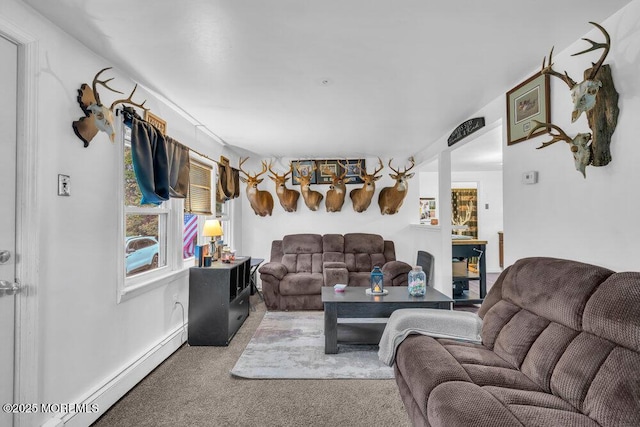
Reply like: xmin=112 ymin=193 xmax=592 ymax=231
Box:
xmin=0 ymin=36 xmax=18 ymax=426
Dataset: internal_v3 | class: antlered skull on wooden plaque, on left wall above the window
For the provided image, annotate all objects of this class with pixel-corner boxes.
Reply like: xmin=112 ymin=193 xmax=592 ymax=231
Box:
xmin=72 ymin=67 xmax=148 ymax=147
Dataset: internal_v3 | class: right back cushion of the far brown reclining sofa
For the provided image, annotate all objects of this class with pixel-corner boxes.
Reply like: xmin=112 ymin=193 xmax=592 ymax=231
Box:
xmin=344 ymin=233 xmax=387 ymax=272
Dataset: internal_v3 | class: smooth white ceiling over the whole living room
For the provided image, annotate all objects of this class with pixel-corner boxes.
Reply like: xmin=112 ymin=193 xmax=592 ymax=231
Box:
xmin=24 ymin=0 xmax=630 ymax=164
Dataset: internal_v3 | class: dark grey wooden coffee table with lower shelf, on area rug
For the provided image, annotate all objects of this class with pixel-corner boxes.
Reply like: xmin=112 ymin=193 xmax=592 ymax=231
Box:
xmin=322 ymin=286 xmax=453 ymax=354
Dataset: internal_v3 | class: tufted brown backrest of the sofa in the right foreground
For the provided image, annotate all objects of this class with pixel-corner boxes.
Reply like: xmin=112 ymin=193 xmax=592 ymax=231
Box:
xmin=482 ymin=258 xmax=640 ymax=425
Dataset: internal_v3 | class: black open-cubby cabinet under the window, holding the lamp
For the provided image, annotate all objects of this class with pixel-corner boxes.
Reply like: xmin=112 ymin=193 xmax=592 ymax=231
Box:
xmin=187 ymin=257 xmax=251 ymax=346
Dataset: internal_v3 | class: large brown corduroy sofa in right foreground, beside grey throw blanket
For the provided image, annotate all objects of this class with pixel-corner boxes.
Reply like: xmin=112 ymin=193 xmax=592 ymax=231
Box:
xmin=395 ymin=258 xmax=640 ymax=427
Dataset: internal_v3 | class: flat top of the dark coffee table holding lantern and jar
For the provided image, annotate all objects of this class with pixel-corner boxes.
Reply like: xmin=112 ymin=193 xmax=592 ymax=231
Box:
xmin=322 ymin=286 xmax=453 ymax=303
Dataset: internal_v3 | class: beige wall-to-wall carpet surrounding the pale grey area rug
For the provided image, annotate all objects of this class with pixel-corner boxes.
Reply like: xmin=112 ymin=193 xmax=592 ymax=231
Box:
xmin=95 ymin=295 xmax=411 ymax=427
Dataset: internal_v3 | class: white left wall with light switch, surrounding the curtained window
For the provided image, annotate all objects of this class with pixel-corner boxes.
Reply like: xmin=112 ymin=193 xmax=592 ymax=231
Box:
xmin=0 ymin=0 xmax=242 ymax=425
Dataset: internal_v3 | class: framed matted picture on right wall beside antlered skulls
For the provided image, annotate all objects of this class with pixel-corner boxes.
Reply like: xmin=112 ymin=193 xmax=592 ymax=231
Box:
xmin=507 ymin=72 xmax=551 ymax=145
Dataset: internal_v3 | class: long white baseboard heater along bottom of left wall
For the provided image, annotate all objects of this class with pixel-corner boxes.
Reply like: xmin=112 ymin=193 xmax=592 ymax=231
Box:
xmin=42 ymin=324 xmax=188 ymax=427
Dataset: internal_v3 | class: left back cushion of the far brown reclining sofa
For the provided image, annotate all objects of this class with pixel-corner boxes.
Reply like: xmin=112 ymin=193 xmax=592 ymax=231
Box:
xmin=281 ymin=234 xmax=322 ymax=273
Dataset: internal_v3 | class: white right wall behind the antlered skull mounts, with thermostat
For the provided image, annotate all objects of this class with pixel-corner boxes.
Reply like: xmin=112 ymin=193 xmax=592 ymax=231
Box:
xmin=504 ymin=1 xmax=640 ymax=271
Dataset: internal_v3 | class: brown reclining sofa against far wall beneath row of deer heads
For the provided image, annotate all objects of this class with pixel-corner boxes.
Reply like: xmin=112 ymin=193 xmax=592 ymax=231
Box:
xmin=258 ymin=233 xmax=411 ymax=310
